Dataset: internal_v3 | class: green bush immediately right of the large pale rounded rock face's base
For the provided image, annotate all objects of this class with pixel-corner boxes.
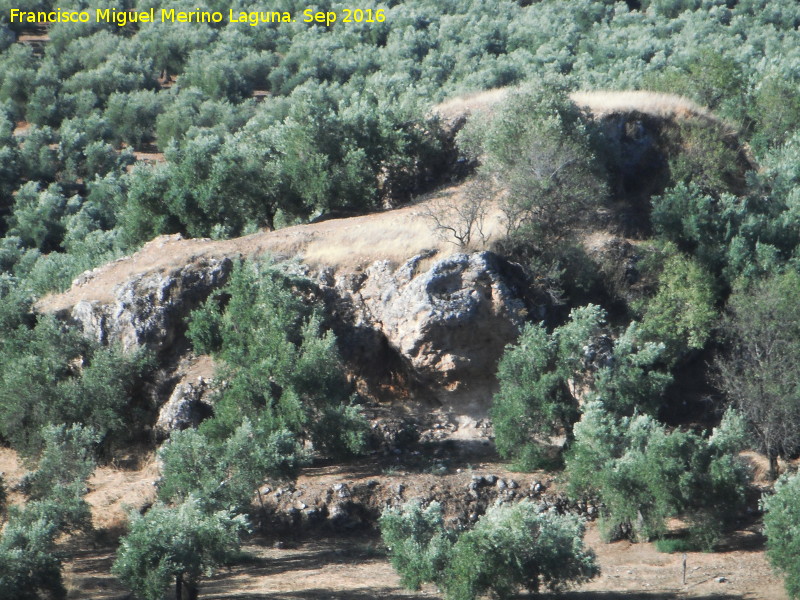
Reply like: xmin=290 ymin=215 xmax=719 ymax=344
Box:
xmin=490 ymin=304 xmax=671 ymax=469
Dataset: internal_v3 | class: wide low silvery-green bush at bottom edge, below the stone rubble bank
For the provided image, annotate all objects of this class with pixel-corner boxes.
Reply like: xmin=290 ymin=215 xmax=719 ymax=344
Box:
xmin=380 ymin=500 xmax=599 ymax=600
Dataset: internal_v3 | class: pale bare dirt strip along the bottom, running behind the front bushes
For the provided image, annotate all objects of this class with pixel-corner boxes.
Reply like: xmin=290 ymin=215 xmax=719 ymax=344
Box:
xmin=62 ymin=525 xmax=788 ymax=600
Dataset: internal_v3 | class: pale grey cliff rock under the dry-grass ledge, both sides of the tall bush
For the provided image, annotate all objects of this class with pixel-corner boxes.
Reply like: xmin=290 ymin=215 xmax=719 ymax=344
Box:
xmin=45 ymin=240 xmax=544 ymax=412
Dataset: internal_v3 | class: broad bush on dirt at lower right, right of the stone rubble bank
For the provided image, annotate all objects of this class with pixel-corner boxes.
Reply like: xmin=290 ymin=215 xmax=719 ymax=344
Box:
xmin=566 ymin=402 xmax=749 ymax=550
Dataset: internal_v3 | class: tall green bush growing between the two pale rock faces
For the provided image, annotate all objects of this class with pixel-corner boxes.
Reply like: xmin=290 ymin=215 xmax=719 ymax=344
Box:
xmin=189 ymin=262 xmax=366 ymax=456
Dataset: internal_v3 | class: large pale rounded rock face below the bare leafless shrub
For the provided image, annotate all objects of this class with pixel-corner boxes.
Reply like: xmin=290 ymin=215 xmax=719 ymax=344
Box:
xmin=320 ymin=252 xmax=544 ymax=406
